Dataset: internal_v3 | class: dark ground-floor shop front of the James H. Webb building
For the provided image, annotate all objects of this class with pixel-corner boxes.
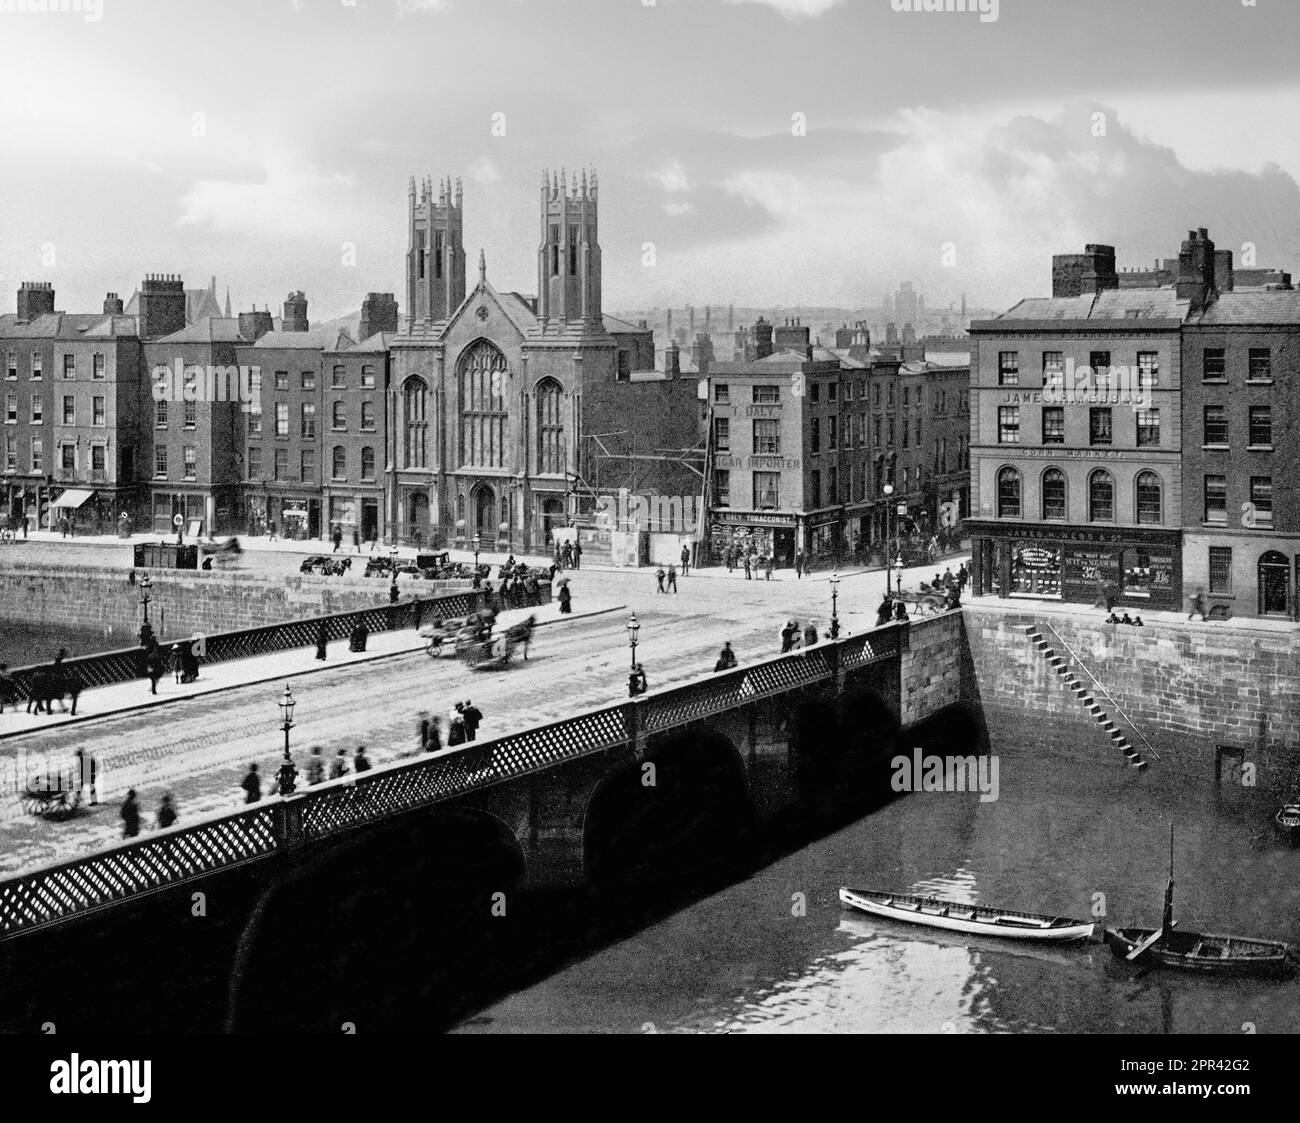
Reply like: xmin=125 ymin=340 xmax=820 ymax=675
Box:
xmin=969 ymin=521 xmax=1183 ymax=610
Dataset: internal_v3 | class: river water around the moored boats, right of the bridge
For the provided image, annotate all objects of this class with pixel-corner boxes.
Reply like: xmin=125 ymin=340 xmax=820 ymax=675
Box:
xmin=459 ymin=740 xmax=1300 ymax=1033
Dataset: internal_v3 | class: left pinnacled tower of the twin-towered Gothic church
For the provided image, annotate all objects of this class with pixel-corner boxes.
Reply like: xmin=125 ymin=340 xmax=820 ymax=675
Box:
xmin=407 ymin=177 xmax=465 ymax=324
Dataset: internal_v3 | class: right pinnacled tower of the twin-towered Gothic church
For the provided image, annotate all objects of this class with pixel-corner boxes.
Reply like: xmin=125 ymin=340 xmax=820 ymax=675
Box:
xmin=537 ymin=170 xmax=602 ymax=331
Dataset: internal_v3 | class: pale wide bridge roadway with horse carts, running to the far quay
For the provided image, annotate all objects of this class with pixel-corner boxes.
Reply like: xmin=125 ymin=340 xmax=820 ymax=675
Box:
xmin=0 ymin=571 xmax=930 ymax=877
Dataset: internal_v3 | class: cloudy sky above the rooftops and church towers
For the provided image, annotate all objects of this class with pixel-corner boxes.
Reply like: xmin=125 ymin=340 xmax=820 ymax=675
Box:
xmin=0 ymin=0 xmax=1300 ymax=320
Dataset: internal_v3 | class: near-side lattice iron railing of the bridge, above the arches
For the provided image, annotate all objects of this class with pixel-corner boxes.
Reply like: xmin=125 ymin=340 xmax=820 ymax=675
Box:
xmin=0 ymin=623 xmax=898 ymax=940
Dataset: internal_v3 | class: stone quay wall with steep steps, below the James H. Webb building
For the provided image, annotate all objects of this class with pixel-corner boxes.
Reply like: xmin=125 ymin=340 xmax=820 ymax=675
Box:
xmin=963 ymin=602 xmax=1300 ymax=789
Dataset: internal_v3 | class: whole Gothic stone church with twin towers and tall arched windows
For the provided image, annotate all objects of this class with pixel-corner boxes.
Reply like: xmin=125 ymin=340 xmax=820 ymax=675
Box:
xmin=386 ymin=172 xmax=654 ymax=551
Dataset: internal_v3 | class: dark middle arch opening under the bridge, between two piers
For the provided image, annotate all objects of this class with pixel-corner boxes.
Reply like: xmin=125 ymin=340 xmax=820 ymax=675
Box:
xmin=582 ymin=724 xmax=754 ymax=888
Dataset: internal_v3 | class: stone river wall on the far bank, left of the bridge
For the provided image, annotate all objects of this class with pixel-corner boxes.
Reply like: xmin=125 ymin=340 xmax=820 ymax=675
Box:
xmin=0 ymin=563 xmax=469 ymax=646
